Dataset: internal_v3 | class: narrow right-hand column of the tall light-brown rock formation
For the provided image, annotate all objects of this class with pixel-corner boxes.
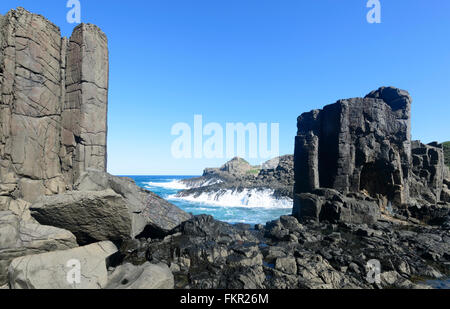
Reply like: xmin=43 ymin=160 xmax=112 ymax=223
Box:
xmin=61 ymin=24 xmax=108 ymax=183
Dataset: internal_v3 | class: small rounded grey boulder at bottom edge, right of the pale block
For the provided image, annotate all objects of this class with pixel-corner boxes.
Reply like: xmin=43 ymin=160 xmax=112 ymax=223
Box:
xmin=105 ymin=262 xmax=174 ymax=290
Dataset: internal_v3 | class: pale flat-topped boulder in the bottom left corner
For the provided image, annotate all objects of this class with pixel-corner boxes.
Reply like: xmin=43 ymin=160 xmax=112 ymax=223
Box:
xmin=8 ymin=241 xmax=117 ymax=289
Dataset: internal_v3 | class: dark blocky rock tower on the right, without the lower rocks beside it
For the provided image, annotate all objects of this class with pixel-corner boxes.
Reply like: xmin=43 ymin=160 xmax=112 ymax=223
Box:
xmin=294 ymin=88 xmax=411 ymax=205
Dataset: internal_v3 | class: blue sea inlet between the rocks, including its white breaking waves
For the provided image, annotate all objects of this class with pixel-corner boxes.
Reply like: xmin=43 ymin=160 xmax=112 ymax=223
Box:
xmin=126 ymin=176 xmax=292 ymax=225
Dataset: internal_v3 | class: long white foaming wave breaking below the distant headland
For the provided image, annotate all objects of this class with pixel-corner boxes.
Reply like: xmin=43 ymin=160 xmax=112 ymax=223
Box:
xmin=168 ymin=189 xmax=293 ymax=209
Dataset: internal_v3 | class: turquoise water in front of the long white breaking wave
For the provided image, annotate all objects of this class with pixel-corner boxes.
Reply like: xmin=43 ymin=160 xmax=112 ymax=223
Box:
xmin=127 ymin=176 xmax=292 ymax=224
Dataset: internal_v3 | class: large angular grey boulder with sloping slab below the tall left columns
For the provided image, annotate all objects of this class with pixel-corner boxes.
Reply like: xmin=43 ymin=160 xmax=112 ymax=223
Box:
xmin=30 ymin=170 xmax=191 ymax=244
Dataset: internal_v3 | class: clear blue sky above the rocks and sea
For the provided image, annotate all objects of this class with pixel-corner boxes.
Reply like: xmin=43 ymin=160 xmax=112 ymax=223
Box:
xmin=0 ymin=0 xmax=450 ymax=175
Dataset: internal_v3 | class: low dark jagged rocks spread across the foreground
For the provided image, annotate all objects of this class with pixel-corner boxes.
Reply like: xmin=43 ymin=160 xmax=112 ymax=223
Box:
xmin=121 ymin=216 xmax=450 ymax=289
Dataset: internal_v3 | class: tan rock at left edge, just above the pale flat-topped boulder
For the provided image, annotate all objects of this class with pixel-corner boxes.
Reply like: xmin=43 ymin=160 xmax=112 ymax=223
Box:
xmin=0 ymin=211 xmax=78 ymax=285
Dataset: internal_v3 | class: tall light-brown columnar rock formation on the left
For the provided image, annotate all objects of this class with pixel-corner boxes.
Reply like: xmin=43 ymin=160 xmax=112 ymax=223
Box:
xmin=0 ymin=8 xmax=108 ymax=209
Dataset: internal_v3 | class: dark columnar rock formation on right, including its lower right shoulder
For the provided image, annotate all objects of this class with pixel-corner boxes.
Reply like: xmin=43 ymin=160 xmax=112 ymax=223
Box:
xmin=294 ymin=87 xmax=446 ymax=221
